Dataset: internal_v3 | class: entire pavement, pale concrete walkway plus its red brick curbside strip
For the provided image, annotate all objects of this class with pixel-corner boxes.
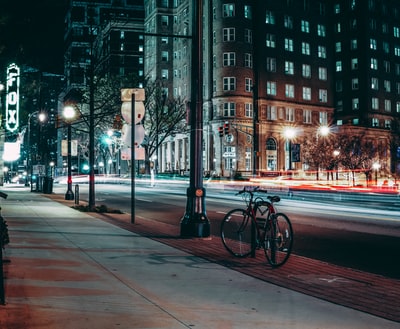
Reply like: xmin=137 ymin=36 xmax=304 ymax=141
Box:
xmin=0 ymin=188 xmax=400 ymax=329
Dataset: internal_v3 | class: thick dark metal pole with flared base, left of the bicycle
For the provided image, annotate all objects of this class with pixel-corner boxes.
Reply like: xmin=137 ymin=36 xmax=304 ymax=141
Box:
xmin=180 ymin=0 xmax=210 ymax=237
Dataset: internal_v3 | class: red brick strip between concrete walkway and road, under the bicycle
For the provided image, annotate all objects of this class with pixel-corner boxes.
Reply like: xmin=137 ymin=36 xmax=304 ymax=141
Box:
xmin=88 ymin=210 xmax=400 ymax=322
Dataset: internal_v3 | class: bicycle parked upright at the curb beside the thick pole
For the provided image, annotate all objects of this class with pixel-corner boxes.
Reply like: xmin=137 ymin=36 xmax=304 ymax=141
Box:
xmin=221 ymin=187 xmax=293 ymax=267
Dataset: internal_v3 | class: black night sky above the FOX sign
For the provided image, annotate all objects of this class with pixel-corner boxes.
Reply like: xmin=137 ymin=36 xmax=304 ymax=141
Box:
xmin=0 ymin=0 xmax=67 ymax=74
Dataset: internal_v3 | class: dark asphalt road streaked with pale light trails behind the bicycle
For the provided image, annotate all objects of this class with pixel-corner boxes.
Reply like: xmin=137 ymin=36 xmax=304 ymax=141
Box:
xmin=57 ymin=184 xmax=400 ymax=279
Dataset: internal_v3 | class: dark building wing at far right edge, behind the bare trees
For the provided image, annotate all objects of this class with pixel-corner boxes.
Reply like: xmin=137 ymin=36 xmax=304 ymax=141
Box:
xmin=330 ymin=0 xmax=400 ymax=174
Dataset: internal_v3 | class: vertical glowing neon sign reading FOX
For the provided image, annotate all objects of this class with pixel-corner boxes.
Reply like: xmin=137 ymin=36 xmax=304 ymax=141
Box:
xmin=6 ymin=64 xmax=20 ymax=132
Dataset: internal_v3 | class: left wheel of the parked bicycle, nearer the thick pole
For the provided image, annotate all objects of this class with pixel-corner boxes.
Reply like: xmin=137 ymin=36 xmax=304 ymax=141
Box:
xmin=221 ymin=209 xmax=256 ymax=257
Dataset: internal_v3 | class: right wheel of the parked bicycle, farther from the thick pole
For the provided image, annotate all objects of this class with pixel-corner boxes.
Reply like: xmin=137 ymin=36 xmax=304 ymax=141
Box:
xmin=264 ymin=213 xmax=293 ymax=267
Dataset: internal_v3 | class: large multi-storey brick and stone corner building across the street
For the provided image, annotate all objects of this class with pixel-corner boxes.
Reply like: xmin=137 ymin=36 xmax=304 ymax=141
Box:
xmin=145 ymin=0 xmax=400 ymax=176
